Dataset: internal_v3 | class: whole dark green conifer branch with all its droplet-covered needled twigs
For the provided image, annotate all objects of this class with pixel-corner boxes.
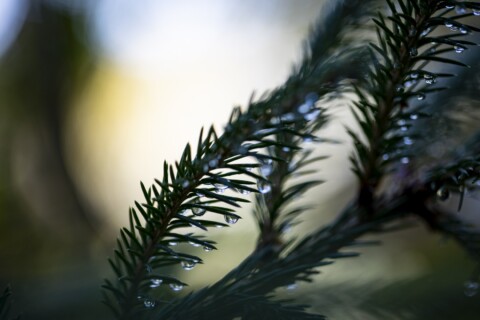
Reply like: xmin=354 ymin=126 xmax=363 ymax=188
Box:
xmin=99 ymin=0 xmax=480 ymax=319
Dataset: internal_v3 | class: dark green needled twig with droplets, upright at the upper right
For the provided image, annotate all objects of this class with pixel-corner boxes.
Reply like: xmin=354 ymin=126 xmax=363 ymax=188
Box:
xmin=349 ymin=0 xmax=478 ymax=215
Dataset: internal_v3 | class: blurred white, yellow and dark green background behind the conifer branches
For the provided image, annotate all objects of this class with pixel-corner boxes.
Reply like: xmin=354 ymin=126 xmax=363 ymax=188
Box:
xmin=0 ymin=0 xmax=480 ymax=320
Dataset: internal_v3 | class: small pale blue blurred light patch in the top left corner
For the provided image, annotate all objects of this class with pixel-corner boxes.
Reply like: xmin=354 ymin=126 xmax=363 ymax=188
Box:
xmin=0 ymin=0 xmax=28 ymax=58
